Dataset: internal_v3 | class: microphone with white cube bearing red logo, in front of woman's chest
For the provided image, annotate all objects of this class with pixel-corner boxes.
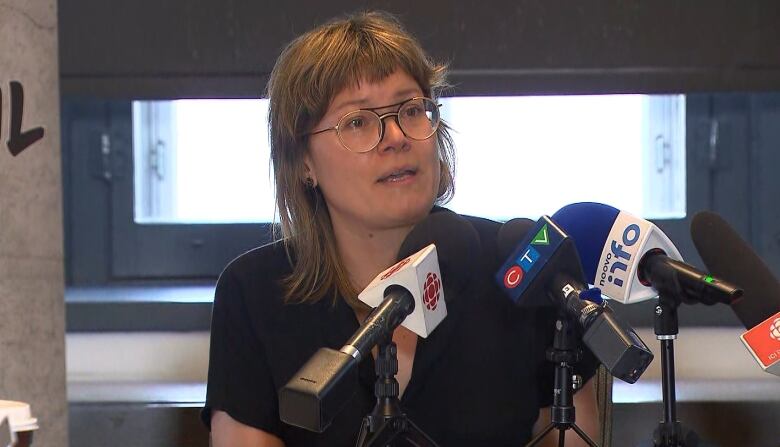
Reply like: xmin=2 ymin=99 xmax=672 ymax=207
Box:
xmin=279 ymin=210 xmax=480 ymax=433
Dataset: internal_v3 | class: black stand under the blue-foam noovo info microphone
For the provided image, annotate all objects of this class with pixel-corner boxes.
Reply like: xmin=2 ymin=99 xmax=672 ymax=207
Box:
xmin=653 ymin=290 xmax=699 ymax=447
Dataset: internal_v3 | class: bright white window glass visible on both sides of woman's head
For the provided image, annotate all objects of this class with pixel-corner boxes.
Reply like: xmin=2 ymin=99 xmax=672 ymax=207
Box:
xmin=133 ymin=95 xmax=685 ymax=223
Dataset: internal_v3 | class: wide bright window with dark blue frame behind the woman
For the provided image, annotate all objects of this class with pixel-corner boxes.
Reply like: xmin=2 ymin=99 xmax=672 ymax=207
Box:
xmin=62 ymin=94 xmax=780 ymax=328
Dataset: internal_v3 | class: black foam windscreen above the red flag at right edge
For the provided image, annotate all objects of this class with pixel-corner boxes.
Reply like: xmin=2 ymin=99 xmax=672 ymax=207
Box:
xmin=691 ymin=211 xmax=780 ymax=329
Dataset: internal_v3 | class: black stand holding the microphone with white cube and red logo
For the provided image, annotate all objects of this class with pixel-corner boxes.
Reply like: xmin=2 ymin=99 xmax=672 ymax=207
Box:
xmin=355 ymin=335 xmax=438 ymax=447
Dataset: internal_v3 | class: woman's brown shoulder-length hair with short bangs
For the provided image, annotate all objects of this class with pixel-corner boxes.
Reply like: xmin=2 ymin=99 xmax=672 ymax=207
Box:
xmin=268 ymin=12 xmax=454 ymax=307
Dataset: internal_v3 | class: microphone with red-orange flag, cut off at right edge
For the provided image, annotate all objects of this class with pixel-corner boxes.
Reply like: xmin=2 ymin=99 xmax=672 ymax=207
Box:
xmin=691 ymin=211 xmax=780 ymax=376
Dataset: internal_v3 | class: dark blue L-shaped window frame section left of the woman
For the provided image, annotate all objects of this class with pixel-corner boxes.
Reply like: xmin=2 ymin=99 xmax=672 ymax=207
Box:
xmin=63 ymin=100 xmax=272 ymax=286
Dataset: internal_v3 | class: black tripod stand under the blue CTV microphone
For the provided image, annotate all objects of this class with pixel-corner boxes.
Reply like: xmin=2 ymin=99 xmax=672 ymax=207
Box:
xmin=526 ymin=312 xmax=598 ymax=447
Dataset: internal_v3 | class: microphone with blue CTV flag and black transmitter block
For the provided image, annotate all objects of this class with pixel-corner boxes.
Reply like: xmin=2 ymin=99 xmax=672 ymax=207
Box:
xmin=495 ymin=216 xmax=653 ymax=383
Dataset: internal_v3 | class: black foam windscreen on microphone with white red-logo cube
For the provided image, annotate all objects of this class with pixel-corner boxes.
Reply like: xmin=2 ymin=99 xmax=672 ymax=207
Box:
xmin=398 ymin=209 xmax=482 ymax=300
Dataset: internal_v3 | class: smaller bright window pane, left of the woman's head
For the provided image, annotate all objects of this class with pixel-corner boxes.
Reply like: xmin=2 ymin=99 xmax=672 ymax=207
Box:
xmin=133 ymin=99 xmax=274 ymax=223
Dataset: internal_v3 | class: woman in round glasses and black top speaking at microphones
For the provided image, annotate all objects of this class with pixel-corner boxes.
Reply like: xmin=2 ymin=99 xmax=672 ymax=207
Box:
xmin=203 ymin=13 xmax=595 ymax=447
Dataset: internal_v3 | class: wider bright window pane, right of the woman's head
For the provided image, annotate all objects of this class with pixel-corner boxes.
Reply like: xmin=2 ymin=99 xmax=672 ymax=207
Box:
xmin=442 ymin=95 xmax=685 ymax=220
